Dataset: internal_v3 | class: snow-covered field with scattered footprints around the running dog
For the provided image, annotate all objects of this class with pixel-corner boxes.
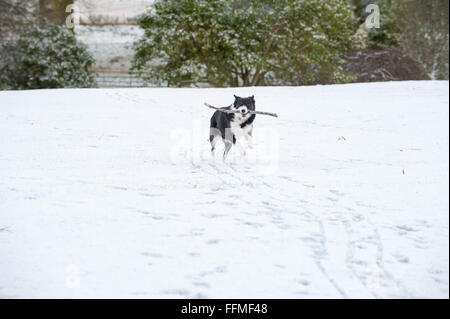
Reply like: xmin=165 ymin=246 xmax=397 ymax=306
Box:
xmin=0 ymin=82 xmax=449 ymax=298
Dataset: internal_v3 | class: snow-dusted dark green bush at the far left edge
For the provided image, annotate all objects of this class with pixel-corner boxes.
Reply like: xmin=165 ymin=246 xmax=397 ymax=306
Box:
xmin=0 ymin=1 xmax=95 ymax=89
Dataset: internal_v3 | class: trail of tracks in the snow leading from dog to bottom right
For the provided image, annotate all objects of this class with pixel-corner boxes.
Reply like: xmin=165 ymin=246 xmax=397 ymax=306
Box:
xmin=190 ymin=158 xmax=411 ymax=298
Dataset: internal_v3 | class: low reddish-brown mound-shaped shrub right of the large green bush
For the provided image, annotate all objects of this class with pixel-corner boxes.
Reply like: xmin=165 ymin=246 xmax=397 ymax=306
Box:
xmin=344 ymin=47 xmax=430 ymax=82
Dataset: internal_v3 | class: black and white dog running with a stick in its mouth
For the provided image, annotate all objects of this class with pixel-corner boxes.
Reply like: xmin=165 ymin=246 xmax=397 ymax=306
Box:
xmin=209 ymin=95 xmax=256 ymax=160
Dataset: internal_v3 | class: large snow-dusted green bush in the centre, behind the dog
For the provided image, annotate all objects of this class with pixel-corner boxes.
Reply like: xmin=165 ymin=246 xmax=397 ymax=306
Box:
xmin=134 ymin=0 xmax=354 ymax=87
